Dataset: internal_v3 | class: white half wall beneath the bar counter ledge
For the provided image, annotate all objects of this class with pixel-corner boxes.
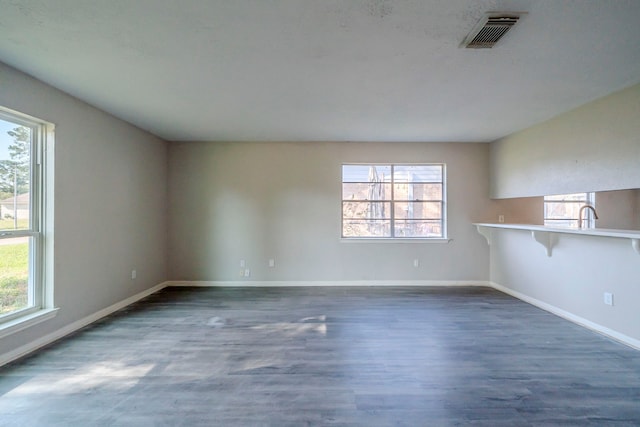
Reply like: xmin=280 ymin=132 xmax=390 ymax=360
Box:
xmin=491 ymin=229 xmax=640 ymax=342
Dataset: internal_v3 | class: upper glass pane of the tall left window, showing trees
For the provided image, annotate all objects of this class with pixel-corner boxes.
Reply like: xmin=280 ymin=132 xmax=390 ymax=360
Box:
xmin=0 ymin=119 xmax=31 ymax=230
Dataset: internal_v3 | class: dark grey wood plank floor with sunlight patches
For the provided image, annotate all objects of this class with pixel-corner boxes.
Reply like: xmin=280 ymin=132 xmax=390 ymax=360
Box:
xmin=0 ymin=288 xmax=640 ymax=426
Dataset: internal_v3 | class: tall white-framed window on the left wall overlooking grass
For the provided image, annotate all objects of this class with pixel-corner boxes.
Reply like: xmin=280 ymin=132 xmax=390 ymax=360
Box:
xmin=0 ymin=109 xmax=52 ymax=330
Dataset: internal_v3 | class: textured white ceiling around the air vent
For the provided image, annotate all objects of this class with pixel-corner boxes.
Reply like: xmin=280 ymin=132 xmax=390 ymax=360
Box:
xmin=0 ymin=0 xmax=640 ymax=142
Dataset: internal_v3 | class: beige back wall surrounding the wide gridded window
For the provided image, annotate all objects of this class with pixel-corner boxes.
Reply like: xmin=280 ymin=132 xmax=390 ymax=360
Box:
xmin=169 ymin=142 xmax=495 ymax=281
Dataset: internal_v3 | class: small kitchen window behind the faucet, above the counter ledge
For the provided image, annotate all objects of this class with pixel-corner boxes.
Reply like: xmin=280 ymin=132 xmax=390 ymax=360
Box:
xmin=544 ymin=193 xmax=595 ymax=228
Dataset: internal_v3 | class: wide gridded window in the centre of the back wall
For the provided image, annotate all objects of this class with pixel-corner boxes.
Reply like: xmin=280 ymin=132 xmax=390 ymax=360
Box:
xmin=342 ymin=163 xmax=447 ymax=239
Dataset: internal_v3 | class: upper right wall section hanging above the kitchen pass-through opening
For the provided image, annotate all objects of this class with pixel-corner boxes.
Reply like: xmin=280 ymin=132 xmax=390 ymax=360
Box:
xmin=491 ymin=84 xmax=640 ymax=198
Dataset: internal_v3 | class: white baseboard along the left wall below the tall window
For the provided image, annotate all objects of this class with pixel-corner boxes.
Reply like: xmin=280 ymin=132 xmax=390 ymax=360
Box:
xmin=0 ymin=282 xmax=167 ymax=366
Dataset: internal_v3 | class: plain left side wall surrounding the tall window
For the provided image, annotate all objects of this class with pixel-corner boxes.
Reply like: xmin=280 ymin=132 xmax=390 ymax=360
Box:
xmin=0 ymin=64 xmax=167 ymax=356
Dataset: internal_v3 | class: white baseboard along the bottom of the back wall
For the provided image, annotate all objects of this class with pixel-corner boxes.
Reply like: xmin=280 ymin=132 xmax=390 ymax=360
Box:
xmin=165 ymin=280 xmax=491 ymax=287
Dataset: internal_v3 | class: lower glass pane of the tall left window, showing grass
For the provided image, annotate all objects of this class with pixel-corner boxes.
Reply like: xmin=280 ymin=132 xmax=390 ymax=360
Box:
xmin=0 ymin=237 xmax=31 ymax=315
